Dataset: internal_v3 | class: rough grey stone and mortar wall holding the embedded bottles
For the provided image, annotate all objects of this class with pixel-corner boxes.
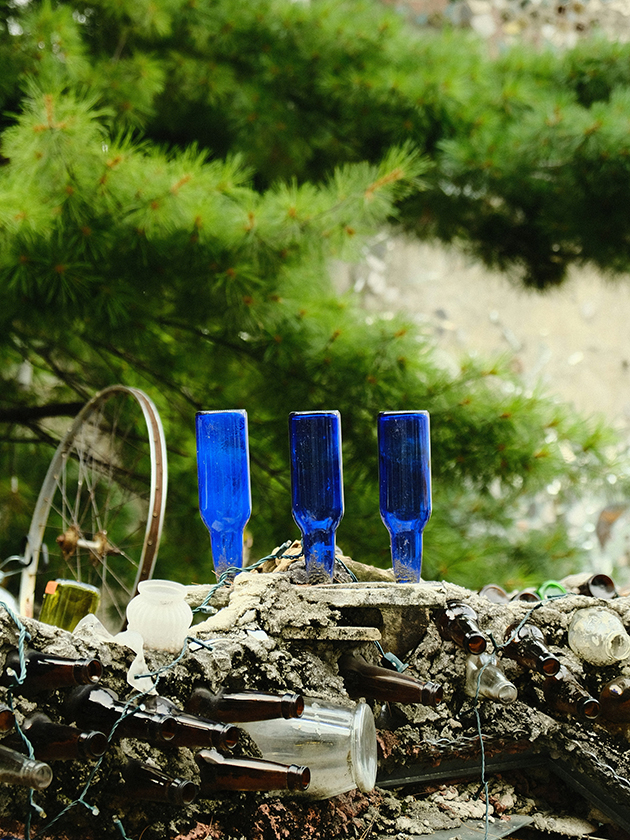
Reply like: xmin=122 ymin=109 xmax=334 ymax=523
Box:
xmin=0 ymin=572 xmax=630 ymax=840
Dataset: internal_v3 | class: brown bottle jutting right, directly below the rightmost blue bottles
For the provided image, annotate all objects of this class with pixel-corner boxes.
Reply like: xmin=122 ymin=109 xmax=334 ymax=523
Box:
xmin=338 ymin=654 xmax=443 ymax=706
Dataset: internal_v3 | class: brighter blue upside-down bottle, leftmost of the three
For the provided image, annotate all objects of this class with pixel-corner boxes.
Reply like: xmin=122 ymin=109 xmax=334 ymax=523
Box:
xmin=195 ymin=410 xmax=252 ymax=577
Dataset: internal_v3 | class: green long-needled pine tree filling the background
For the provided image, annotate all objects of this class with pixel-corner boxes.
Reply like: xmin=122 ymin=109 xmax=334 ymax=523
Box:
xmin=0 ymin=0 xmax=630 ymax=596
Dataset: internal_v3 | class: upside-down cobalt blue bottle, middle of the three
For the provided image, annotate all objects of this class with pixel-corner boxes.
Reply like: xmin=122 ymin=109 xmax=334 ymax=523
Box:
xmin=289 ymin=411 xmax=343 ymax=583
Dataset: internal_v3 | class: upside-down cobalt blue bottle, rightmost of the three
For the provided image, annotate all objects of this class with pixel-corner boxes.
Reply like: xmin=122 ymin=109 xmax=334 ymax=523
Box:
xmin=378 ymin=411 xmax=431 ymax=583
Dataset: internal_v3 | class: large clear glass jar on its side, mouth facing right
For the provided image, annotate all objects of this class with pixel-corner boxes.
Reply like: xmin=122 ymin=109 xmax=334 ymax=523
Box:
xmin=238 ymin=698 xmax=377 ymax=799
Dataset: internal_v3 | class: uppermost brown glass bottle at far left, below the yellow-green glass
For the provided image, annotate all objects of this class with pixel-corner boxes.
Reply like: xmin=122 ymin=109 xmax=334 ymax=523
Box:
xmin=0 ymin=650 xmax=103 ymax=696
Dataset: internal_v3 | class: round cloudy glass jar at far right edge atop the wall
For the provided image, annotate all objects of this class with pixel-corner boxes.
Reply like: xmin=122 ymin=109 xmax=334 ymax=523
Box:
xmin=569 ymin=607 xmax=630 ymax=665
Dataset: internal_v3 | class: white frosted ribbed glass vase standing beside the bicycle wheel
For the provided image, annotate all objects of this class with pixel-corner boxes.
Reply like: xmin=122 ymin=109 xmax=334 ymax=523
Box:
xmin=127 ymin=580 xmax=192 ymax=653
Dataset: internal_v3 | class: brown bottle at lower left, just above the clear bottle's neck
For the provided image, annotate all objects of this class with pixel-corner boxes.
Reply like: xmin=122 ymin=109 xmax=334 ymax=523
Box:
xmin=11 ymin=712 xmax=108 ymax=761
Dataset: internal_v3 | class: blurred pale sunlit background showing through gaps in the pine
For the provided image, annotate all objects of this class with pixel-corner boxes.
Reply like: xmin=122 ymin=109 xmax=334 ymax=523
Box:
xmin=337 ymin=0 xmax=630 ymax=586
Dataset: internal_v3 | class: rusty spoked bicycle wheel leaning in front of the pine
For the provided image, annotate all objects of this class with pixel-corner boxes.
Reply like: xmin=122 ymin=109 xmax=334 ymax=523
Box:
xmin=19 ymin=385 xmax=167 ymax=632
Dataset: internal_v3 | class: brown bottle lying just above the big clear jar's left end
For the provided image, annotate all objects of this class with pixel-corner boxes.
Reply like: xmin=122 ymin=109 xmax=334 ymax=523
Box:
xmin=186 ymin=688 xmax=304 ymax=723
